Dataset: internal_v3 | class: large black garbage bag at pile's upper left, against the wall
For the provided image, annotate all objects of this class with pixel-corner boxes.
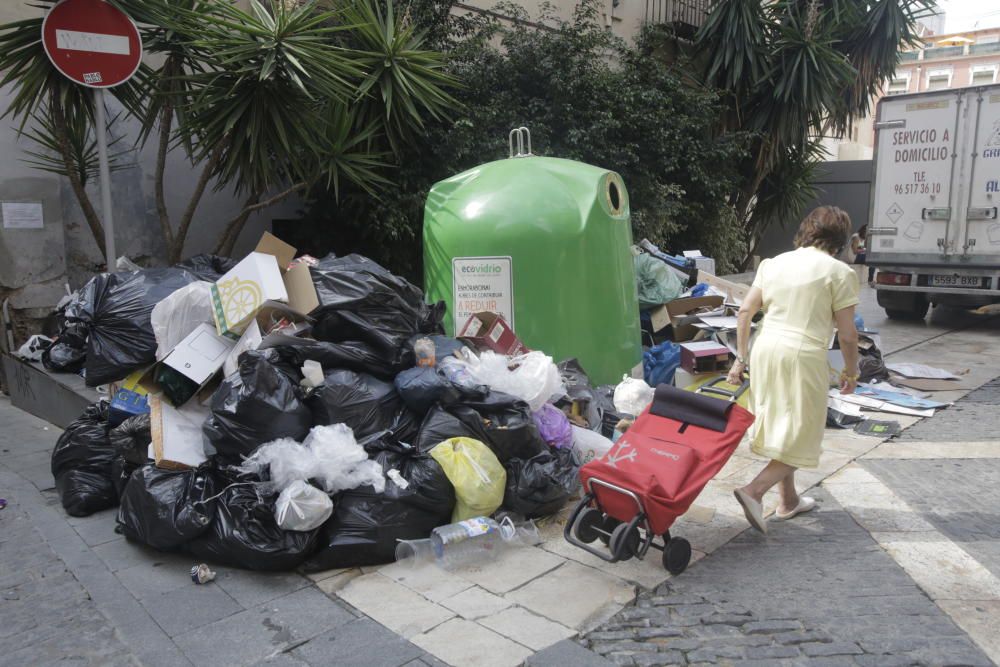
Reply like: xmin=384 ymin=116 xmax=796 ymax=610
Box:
xmin=56 ymin=268 xmax=197 ymax=387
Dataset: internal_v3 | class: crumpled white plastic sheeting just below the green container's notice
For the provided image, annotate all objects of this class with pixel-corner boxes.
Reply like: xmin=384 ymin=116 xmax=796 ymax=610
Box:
xmin=464 ymin=350 xmax=566 ymax=410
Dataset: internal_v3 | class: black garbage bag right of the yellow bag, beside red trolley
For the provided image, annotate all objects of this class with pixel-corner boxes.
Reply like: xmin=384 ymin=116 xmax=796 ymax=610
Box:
xmin=503 ymin=447 xmax=580 ymax=519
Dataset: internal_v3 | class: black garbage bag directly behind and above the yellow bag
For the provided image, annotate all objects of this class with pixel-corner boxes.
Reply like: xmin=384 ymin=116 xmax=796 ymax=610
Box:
xmin=417 ymin=391 xmax=549 ymax=463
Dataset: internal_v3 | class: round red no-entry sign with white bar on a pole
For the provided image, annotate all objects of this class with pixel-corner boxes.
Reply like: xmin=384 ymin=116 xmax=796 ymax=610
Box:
xmin=42 ymin=0 xmax=142 ymax=88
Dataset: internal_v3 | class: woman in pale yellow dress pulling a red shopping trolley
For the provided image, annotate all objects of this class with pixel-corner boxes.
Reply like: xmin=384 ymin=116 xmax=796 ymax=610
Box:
xmin=729 ymin=206 xmax=858 ymax=533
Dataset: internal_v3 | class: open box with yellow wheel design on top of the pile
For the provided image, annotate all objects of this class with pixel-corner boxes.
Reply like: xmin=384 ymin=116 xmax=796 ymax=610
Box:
xmin=212 ymin=232 xmax=319 ymax=340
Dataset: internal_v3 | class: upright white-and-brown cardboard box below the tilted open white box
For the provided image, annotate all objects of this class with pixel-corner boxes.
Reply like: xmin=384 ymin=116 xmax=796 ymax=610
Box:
xmin=149 ymin=396 xmax=208 ymax=470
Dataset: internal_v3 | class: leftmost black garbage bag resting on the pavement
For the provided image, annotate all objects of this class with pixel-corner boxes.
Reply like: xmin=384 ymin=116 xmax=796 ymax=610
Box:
xmin=52 ymin=401 xmax=118 ymax=516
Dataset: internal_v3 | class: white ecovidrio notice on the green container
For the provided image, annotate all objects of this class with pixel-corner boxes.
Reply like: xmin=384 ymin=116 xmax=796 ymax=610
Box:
xmin=451 ymin=257 xmax=515 ymax=331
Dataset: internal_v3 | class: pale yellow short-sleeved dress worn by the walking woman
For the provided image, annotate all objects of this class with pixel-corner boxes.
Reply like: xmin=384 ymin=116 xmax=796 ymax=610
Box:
xmin=750 ymin=248 xmax=858 ymax=468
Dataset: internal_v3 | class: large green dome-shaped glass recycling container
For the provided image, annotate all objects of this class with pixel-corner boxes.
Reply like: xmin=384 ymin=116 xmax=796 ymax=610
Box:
xmin=424 ymin=155 xmax=642 ymax=384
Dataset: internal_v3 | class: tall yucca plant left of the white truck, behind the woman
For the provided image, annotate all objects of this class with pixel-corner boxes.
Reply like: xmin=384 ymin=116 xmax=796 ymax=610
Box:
xmin=696 ymin=0 xmax=935 ymax=266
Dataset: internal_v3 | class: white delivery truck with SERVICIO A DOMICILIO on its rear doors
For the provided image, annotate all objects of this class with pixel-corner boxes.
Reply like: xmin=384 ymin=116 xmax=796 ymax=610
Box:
xmin=867 ymin=85 xmax=1000 ymax=319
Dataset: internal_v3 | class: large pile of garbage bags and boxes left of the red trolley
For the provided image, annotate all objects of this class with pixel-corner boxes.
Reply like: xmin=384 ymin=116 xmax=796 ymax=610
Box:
xmin=42 ymin=235 xmax=623 ymax=571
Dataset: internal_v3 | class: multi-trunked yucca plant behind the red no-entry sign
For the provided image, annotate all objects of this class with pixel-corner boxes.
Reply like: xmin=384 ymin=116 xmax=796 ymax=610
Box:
xmin=0 ymin=0 xmax=454 ymax=262
